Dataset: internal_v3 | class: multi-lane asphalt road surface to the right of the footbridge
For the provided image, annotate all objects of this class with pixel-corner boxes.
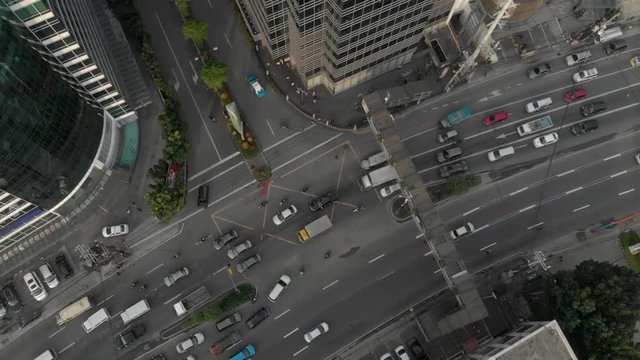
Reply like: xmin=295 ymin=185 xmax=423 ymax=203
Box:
xmin=396 ymin=37 xmax=640 ymax=269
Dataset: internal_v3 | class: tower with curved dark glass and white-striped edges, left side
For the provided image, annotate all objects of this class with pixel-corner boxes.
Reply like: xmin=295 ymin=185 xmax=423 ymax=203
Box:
xmin=0 ymin=0 xmax=150 ymax=253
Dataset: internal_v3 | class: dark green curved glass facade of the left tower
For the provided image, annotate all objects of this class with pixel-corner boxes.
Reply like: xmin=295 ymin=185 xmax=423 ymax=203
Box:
xmin=0 ymin=21 xmax=103 ymax=211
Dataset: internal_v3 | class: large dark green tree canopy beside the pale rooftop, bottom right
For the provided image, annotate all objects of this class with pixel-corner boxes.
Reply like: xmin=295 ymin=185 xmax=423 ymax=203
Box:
xmin=529 ymin=260 xmax=640 ymax=360
